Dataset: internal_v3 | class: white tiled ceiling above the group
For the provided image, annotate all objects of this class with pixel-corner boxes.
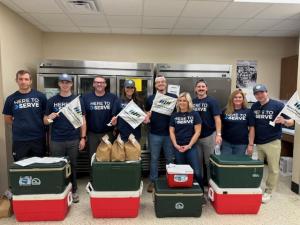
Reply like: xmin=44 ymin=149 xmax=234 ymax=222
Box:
xmin=0 ymin=0 xmax=300 ymax=37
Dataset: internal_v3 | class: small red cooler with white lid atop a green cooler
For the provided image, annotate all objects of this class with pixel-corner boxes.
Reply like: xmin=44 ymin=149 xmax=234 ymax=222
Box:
xmin=166 ymin=164 xmax=194 ymax=188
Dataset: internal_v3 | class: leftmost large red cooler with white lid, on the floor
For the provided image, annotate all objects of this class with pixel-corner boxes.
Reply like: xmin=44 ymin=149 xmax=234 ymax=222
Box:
xmin=12 ymin=183 xmax=72 ymax=222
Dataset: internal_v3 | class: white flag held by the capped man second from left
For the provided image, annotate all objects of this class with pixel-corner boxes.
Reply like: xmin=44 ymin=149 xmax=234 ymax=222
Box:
xmin=59 ymin=96 xmax=83 ymax=129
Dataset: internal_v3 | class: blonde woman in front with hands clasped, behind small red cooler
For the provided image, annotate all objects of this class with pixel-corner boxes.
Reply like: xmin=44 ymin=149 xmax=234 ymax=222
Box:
xmin=169 ymin=92 xmax=203 ymax=189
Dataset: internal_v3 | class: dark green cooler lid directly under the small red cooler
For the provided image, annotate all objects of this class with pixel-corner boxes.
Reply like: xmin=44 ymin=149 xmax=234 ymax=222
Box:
xmin=154 ymin=178 xmax=203 ymax=195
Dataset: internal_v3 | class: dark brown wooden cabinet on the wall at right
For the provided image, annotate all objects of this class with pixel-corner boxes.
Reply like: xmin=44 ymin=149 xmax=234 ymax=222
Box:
xmin=279 ymin=55 xmax=298 ymax=100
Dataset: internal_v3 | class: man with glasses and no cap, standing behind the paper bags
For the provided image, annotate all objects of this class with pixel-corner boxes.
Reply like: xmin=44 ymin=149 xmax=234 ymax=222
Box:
xmin=83 ymin=76 xmax=119 ymax=157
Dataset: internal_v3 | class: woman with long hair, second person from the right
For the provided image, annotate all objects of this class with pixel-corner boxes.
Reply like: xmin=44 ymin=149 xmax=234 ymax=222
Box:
xmin=221 ymin=89 xmax=255 ymax=155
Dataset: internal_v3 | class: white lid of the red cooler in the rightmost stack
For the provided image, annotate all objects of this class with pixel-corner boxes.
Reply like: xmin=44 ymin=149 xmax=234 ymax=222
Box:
xmin=209 ymin=179 xmax=262 ymax=194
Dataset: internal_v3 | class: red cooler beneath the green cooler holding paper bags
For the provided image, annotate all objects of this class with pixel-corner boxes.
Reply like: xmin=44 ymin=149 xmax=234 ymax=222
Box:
xmin=86 ymin=182 xmax=143 ymax=218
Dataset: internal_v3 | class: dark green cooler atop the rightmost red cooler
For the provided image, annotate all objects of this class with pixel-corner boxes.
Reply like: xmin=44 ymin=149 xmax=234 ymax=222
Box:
xmin=209 ymin=155 xmax=264 ymax=188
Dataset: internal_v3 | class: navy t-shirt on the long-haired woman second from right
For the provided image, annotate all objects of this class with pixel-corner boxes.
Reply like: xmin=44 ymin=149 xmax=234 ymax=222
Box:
xmin=221 ymin=108 xmax=255 ymax=145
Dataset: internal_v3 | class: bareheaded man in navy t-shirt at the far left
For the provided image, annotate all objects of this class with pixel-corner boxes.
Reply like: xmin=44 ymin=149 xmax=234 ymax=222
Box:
xmin=2 ymin=70 xmax=47 ymax=161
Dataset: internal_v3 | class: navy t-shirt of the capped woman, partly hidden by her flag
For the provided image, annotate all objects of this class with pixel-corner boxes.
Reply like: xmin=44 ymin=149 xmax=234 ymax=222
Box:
xmin=117 ymin=99 xmax=141 ymax=142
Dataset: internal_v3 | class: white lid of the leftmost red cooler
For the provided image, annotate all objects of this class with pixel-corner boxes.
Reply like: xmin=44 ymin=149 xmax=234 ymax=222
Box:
xmin=13 ymin=183 xmax=72 ymax=201
